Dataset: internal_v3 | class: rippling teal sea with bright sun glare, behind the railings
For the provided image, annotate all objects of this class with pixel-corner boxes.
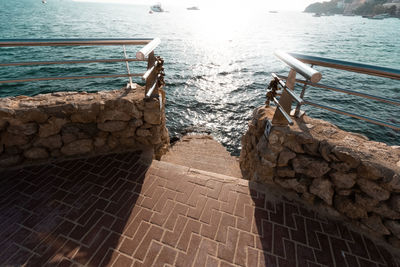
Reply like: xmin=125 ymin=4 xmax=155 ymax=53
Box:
xmin=0 ymin=0 xmax=400 ymax=155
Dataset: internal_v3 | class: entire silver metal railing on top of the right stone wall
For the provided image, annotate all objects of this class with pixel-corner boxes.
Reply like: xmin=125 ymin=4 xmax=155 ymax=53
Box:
xmin=272 ymin=52 xmax=400 ymax=130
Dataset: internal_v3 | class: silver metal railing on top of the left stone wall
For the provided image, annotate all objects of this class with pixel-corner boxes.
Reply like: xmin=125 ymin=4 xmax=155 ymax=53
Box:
xmin=0 ymin=38 xmax=161 ymax=96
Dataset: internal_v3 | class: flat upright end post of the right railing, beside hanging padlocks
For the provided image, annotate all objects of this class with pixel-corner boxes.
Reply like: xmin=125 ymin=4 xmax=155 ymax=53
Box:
xmin=272 ymin=69 xmax=296 ymax=125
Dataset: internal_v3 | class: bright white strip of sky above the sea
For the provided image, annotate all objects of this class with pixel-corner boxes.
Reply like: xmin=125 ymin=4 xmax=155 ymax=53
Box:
xmin=74 ymin=0 xmax=318 ymax=11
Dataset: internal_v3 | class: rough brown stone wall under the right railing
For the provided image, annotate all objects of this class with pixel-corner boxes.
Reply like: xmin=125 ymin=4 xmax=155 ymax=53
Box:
xmin=240 ymin=107 xmax=400 ymax=247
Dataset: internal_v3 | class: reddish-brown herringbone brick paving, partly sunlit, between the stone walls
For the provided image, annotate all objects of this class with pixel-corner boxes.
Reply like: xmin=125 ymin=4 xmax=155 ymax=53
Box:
xmin=0 ymin=152 xmax=399 ymax=267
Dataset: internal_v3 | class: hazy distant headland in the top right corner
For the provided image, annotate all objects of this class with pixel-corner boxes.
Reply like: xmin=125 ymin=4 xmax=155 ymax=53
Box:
xmin=304 ymin=0 xmax=400 ymax=18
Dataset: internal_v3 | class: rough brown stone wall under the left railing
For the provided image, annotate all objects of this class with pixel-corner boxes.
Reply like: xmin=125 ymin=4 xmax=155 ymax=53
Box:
xmin=0 ymin=86 xmax=169 ymax=168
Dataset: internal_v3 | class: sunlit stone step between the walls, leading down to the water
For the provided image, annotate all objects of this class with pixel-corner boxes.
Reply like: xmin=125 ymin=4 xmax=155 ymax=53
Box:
xmin=161 ymin=135 xmax=242 ymax=178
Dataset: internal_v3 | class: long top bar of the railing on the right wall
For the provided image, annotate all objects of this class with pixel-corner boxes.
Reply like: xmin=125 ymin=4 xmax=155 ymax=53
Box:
xmin=290 ymin=53 xmax=400 ymax=82
